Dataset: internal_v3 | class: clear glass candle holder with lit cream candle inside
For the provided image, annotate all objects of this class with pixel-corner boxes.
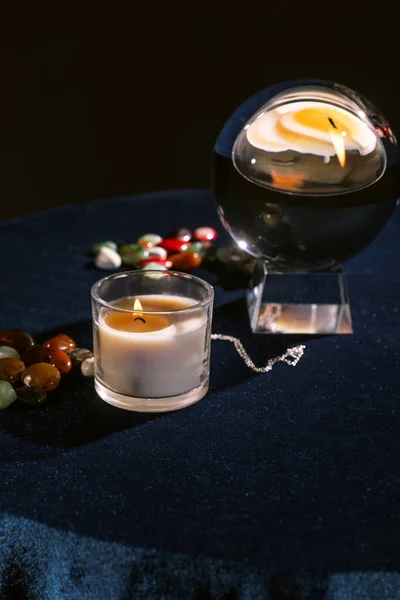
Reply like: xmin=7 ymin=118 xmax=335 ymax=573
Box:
xmin=92 ymin=271 xmax=214 ymax=412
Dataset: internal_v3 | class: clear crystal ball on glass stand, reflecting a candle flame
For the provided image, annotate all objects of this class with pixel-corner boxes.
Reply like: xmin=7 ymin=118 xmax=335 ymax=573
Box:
xmin=212 ymin=80 xmax=399 ymax=270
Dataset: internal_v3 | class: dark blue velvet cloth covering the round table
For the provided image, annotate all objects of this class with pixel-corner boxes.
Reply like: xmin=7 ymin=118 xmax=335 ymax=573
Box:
xmin=0 ymin=191 xmax=400 ymax=600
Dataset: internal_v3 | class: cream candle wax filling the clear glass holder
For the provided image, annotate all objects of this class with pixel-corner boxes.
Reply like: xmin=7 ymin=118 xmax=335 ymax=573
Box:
xmin=96 ymin=295 xmax=208 ymax=398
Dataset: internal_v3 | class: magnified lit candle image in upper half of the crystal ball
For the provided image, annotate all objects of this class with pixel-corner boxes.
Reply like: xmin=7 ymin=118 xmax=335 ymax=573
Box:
xmin=234 ymin=101 xmax=384 ymax=193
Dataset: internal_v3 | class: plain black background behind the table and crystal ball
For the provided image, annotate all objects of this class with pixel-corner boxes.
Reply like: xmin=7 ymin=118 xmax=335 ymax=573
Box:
xmin=0 ymin=8 xmax=400 ymax=219
